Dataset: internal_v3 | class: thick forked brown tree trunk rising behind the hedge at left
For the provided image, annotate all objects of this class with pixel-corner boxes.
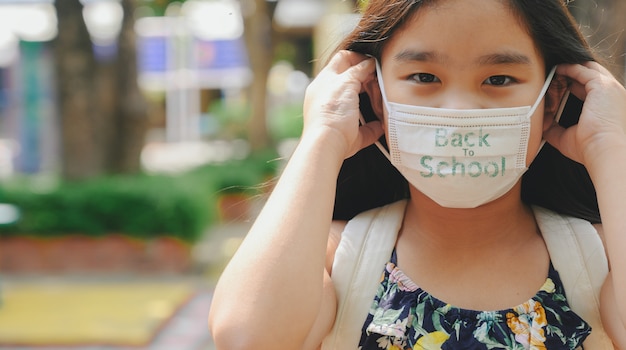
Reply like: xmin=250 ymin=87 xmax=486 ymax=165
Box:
xmin=54 ymin=0 xmax=147 ymax=180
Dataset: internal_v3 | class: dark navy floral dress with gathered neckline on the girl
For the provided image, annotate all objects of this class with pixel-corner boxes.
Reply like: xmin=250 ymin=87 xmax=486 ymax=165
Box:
xmin=359 ymin=251 xmax=591 ymax=350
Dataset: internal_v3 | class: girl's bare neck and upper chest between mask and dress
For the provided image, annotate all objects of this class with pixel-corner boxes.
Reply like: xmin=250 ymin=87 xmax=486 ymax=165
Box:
xmin=396 ymin=186 xmax=550 ymax=310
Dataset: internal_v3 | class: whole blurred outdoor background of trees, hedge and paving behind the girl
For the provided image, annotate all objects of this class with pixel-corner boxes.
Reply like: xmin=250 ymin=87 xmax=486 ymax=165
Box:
xmin=0 ymin=0 xmax=626 ymax=349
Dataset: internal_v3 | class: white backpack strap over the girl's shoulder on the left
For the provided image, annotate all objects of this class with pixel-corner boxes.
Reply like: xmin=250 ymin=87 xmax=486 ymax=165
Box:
xmin=322 ymin=201 xmax=406 ymax=350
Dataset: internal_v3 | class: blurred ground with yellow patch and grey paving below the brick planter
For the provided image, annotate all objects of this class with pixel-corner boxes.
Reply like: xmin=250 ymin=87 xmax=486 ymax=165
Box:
xmin=0 ymin=220 xmax=251 ymax=350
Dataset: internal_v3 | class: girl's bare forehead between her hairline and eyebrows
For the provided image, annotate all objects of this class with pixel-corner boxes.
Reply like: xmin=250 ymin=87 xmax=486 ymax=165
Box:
xmin=383 ymin=0 xmax=540 ymax=63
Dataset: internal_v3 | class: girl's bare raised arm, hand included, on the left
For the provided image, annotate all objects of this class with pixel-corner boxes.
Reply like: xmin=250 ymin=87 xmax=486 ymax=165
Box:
xmin=209 ymin=51 xmax=382 ymax=350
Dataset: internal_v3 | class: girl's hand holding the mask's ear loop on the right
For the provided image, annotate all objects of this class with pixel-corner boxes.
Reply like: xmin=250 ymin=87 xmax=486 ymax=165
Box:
xmin=543 ymin=62 xmax=626 ymax=167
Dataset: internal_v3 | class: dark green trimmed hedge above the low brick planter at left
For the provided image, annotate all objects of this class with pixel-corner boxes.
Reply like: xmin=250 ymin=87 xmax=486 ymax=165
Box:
xmin=2 ymin=175 xmax=211 ymax=241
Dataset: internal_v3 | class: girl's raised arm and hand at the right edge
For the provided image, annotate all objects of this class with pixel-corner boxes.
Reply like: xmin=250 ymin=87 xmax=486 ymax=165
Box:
xmin=544 ymin=62 xmax=626 ymax=349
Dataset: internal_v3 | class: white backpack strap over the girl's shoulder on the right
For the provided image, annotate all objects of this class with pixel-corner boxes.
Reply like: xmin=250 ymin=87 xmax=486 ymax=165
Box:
xmin=533 ymin=207 xmax=614 ymax=350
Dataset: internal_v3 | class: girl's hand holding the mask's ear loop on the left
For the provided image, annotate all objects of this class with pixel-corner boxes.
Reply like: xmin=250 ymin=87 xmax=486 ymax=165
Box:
xmin=303 ymin=51 xmax=383 ymax=158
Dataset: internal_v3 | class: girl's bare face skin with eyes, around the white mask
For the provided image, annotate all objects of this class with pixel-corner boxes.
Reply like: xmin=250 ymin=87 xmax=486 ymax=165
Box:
xmin=370 ymin=0 xmax=546 ymax=163
